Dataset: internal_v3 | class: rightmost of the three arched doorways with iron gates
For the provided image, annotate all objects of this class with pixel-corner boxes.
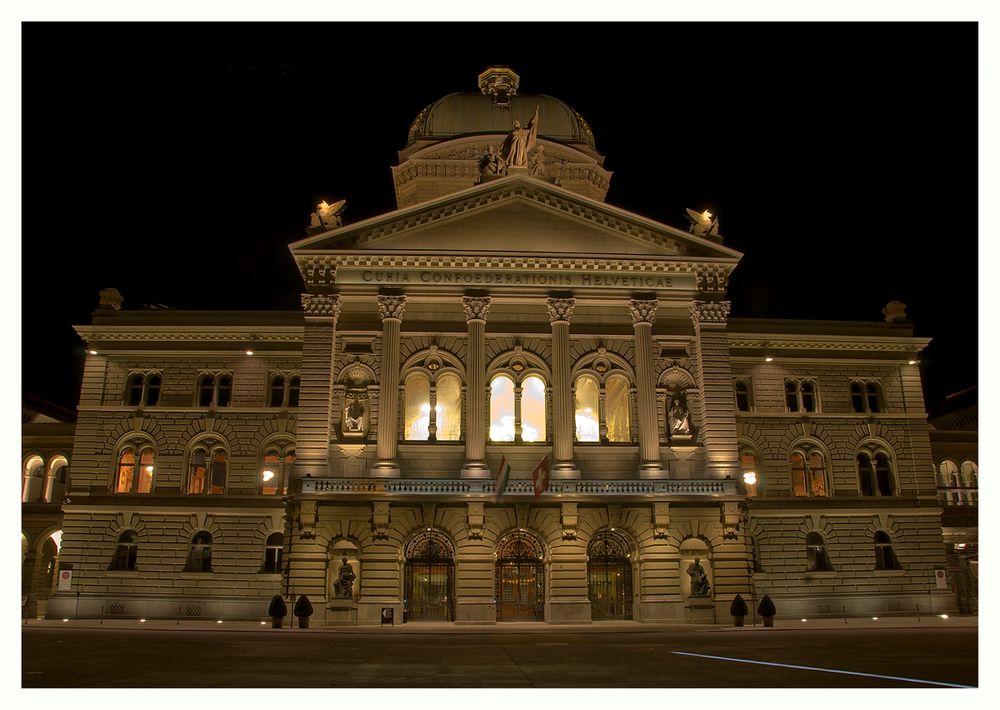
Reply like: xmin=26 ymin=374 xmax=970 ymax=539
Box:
xmin=587 ymin=530 xmax=632 ymax=621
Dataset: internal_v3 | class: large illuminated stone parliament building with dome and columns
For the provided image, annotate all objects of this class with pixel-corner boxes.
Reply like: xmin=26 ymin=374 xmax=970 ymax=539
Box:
xmin=22 ymin=67 xmax=964 ymax=626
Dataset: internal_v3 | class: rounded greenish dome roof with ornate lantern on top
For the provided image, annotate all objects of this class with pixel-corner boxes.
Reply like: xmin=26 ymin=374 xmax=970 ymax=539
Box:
xmin=407 ymin=67 xmax=594 ymax=148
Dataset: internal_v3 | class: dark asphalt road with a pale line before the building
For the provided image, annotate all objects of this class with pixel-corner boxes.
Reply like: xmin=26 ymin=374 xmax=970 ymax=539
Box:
xmin=21 ymin=627 xmax=978 ymax=688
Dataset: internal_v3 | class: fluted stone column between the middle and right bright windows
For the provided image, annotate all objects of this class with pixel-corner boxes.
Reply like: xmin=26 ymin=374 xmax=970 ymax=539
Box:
xmin=547 ymin=298 xmax=580 ymax=478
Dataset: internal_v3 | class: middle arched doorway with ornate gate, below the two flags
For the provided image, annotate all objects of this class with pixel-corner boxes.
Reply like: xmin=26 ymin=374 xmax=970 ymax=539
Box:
xmin=496 ymin=530 xmax=545 ymax=621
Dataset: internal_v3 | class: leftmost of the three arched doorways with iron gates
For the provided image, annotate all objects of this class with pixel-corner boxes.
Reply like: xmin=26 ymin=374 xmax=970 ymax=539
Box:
xmin=403 ymin=530 xmax=455 ymax=621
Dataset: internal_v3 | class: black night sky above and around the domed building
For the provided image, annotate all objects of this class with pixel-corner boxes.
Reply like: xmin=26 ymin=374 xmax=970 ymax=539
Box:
xmin=21 ymin=23 xmax=978 ymax=407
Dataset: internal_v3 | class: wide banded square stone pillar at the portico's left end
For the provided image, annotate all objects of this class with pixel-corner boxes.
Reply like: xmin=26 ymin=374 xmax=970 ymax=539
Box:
xmin=289 ymin=293 xmax=341 ymax=482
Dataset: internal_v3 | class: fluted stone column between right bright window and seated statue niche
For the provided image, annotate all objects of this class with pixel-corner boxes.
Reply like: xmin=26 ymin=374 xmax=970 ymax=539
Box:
xmin=628 ymin=299 xmax=666 ymax=478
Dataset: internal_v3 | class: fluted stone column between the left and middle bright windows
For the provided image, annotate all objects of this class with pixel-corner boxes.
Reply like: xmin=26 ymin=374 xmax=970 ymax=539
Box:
xmin=462 ymin=296 xmax=493 ymax=478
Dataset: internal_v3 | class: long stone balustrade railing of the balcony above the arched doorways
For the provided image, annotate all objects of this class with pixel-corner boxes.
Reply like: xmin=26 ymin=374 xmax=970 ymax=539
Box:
xmin=302 ymin=477 xmax=736 ymax=498
